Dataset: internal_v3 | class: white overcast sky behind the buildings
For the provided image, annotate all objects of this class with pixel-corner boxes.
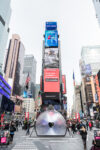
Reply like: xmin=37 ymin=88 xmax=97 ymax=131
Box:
xmin=9 ymin=0 xmax=100 ymax=108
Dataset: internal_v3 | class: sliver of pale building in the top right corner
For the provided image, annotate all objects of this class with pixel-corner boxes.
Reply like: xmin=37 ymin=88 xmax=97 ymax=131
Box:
xmin=93 ymin=0 xmax=100 ymax=25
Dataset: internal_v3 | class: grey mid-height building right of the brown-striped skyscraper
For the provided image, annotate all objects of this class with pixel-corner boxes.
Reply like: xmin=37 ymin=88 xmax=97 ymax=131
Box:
xmin=22 ymin=55 xmax=36 ymax=99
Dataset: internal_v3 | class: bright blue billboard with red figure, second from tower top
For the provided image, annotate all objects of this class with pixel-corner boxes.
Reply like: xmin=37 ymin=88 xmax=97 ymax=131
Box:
xmin=45 ymin=30 xmax=58 ymax=47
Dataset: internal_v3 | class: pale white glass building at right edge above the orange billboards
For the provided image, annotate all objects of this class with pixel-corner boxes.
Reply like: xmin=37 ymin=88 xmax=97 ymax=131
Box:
xmin=81 ymin=46 xmax=100 ymax=75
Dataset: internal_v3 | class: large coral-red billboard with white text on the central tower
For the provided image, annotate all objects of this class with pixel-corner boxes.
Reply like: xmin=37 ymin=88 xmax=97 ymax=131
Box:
xmin=44 ymin=68 xmax=60 ymax=93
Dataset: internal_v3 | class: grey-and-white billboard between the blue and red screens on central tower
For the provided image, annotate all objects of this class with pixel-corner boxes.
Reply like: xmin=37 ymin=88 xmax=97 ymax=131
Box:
xmin=44 ymin=48 xmax=59 ymax=68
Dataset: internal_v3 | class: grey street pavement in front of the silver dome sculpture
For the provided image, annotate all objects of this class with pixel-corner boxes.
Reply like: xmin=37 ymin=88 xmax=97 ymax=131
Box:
xmin=0 ymin=126 xmax=93 ymax=150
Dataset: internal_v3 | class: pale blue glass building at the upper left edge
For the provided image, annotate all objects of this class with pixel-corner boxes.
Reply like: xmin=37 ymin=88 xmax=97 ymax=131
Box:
xmin=0 ymin=0 xmax=11 ymax=73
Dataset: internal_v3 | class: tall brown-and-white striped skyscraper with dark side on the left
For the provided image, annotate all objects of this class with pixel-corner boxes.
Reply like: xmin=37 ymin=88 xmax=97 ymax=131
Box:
xmin=4 ymin=34 xmax=25 ymax=95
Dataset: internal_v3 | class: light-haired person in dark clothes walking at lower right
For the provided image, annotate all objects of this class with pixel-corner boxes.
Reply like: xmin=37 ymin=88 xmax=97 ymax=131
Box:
xmin=80 ymin=126 xmax=87 ymax=150
